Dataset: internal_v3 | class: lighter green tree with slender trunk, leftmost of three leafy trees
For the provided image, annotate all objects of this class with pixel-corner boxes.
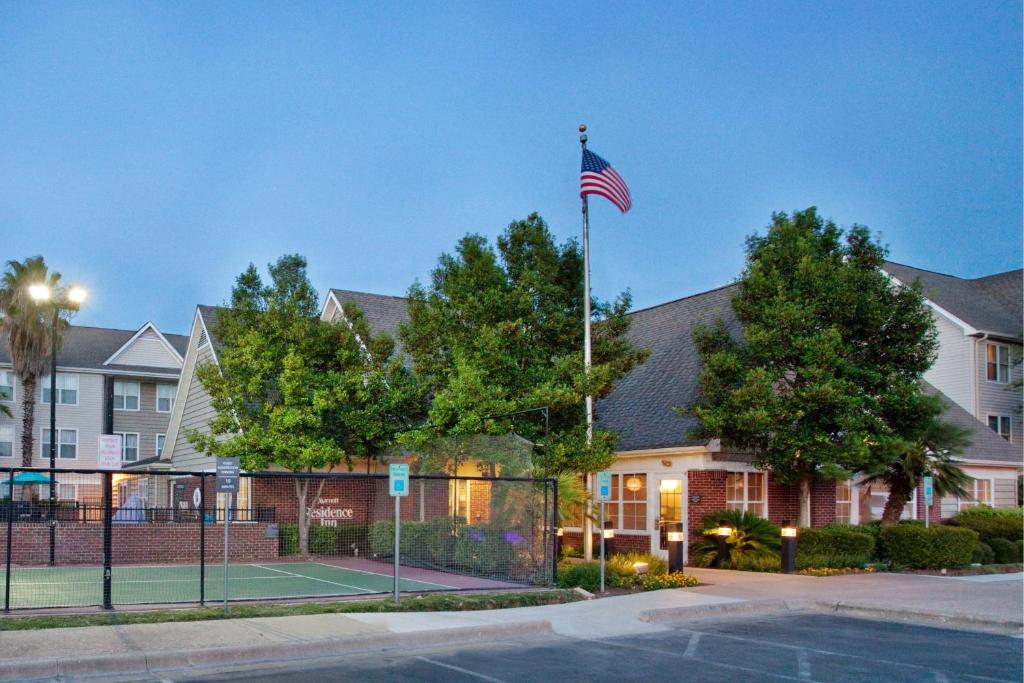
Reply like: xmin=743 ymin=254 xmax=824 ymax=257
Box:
xmin=188 ymin=255 xmax=423 ymax=554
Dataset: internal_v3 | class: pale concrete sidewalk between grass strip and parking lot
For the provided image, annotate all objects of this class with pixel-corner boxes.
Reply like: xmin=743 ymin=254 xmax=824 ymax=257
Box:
xmin=0 ymin=569 xmax=1024 ymax=681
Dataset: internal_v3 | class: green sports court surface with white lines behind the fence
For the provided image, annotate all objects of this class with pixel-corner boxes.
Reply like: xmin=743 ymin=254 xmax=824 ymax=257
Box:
xmin=0 ymin=562 xmax=452 ymax=609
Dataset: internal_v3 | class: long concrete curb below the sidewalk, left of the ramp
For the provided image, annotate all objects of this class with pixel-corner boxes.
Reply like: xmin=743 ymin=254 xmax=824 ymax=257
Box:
xmin=0 ymin=621 xmax=553 ymax=681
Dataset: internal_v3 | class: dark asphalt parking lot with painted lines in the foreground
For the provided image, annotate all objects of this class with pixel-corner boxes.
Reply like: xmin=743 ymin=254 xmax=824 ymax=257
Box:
xmin=161 ymin=612 xmax=1024 ymax=683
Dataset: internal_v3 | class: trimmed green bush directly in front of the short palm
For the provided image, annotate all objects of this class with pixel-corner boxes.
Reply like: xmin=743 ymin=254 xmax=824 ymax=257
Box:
xmin=880 ymin=524 xmax=978 ymax=569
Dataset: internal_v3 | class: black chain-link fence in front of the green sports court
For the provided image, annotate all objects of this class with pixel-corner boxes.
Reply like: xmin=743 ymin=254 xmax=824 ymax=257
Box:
xmin=0 ymin=468 xmax=558 ymax=611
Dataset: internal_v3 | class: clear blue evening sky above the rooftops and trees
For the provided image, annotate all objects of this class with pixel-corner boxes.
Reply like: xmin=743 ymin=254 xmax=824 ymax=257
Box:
xmin=0 ymin=0 xmax=1022 ymax=332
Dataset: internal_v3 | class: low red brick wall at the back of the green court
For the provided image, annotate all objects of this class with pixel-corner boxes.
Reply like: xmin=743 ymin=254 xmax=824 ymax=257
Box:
xmin=3 ymin=523 xmax=278 ymax=566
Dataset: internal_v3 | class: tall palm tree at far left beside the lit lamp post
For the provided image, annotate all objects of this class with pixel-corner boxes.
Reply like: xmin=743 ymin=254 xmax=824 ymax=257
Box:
xmin=0 ymin=256 xmax=68 ymax=475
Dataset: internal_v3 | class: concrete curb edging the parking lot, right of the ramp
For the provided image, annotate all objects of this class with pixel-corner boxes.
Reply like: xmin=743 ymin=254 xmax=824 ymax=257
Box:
xmin=639 ymin=600 xmax=1024 ymax=635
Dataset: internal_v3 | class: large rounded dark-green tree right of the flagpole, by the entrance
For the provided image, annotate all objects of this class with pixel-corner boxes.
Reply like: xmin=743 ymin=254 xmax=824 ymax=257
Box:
xmin=690 ymin=207 xmax=936 ymax=525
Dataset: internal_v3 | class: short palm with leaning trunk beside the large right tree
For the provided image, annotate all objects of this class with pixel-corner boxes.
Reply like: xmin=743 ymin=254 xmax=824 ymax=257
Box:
xmin=861 ymin=417 xmax=972 ymax=526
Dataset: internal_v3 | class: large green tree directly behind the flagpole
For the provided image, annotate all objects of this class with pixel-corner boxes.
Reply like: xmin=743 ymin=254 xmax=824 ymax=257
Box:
xmin=399 ymin=213 xmax=646 ymax=473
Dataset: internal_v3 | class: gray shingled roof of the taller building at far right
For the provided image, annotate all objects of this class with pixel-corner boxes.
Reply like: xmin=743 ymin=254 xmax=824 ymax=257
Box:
xmin=884 ymin=261 xmax=1024 ymax=339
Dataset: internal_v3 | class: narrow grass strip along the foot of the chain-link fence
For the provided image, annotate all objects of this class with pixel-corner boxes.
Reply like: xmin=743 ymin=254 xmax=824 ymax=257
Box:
xmin=0 ymin=591 xmax=580 ymax=631
